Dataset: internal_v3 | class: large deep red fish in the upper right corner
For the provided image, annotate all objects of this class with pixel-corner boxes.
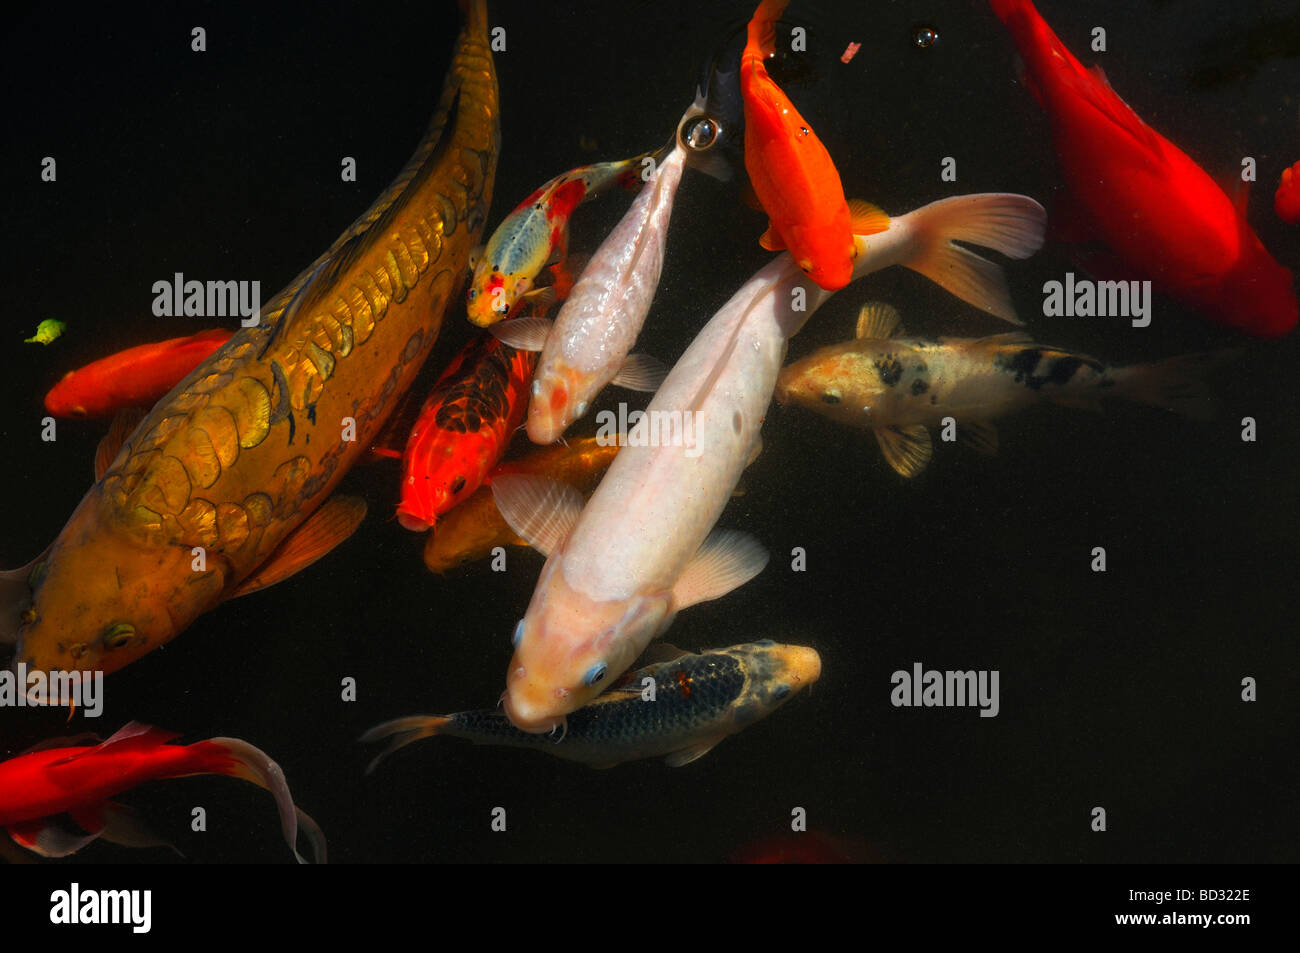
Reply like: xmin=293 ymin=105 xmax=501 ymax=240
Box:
xmin=991 ymin=0 xmax=1300 ymax=337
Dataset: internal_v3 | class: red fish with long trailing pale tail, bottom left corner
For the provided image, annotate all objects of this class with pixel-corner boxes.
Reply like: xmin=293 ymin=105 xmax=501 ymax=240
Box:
xmin=0 ymin=722 xmax=325 ymax=863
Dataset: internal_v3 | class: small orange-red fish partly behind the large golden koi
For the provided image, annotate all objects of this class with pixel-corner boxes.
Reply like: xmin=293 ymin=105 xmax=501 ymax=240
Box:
xmin=46 ymin=328 xmax=234 ymax=417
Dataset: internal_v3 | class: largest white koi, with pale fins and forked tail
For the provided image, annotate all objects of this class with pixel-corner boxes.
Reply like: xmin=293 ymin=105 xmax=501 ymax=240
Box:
xmin=493 ymin=189 xmax=1045 ymax=732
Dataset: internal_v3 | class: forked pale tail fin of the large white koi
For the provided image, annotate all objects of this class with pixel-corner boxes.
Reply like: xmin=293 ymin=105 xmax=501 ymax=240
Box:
xmin=902 ymin=192 xmax=1047 ymax=324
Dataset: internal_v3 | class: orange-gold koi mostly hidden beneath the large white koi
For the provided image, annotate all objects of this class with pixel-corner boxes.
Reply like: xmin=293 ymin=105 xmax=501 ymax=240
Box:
xmin=424 ymin=437 xmax=619 ymax=573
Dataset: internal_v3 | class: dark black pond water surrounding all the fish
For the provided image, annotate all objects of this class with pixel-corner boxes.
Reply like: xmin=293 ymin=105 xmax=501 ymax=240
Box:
xmin=0 ymin=0 xmax=1300 ymax=863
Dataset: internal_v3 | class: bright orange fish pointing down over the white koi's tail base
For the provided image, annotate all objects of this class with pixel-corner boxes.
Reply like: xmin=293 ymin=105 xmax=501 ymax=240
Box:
xmin=740 ymin=0 xmax=885 ymax=291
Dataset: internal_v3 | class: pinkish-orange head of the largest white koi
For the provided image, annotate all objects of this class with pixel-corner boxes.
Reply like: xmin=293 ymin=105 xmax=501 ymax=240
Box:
xmin=503 ymin=555 xmax=672 ymax=733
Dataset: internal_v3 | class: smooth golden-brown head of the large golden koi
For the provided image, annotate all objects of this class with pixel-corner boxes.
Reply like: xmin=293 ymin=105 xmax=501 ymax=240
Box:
xmin=14 ymin=490 xmax=225 ymax=673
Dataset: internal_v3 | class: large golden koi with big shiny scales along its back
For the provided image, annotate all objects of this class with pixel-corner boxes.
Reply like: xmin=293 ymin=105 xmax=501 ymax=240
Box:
xmin=0 ymin=0 xmax=501 ymax=672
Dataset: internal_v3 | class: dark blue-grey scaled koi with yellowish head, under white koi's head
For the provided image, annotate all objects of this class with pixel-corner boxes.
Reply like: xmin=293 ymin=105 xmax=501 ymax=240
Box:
xmin=367 ymin=641 xmax=822 ymax=767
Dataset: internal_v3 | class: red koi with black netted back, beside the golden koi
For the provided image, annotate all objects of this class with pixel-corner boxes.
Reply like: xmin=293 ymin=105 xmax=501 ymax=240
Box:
xmin=398 ymin=328 xmax=537 ymax=532
